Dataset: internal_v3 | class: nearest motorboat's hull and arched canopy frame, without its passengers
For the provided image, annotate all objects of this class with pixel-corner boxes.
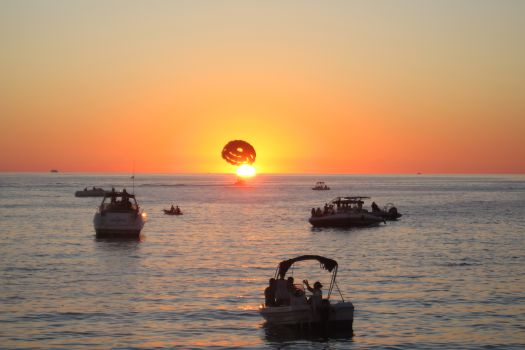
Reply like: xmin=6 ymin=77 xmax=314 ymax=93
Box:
xmin=259 ymin=255 xmax=354 ymax=331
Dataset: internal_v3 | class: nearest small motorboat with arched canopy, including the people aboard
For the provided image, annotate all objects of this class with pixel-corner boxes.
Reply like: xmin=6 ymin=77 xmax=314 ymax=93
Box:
xmin=259 ymin=255 xmax=354 ymax=332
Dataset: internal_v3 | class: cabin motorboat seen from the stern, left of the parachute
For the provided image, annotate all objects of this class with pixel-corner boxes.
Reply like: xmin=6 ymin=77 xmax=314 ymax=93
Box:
xmin=93 ymin=189 xmax=147 ymax=238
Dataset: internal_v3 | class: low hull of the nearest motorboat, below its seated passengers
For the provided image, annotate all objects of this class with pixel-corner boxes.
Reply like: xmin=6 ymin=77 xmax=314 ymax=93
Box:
xmin=259 ymin=302 xmax=354 ymax=330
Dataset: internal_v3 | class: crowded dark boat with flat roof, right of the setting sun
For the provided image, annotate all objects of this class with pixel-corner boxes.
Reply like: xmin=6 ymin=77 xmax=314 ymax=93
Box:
xmin=308 ymin=197 xmax=385 ymax=227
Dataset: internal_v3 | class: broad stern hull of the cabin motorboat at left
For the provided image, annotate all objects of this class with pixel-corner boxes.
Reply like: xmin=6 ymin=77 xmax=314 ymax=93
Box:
xmin=93 ymin=212 xmax=145 ymax=238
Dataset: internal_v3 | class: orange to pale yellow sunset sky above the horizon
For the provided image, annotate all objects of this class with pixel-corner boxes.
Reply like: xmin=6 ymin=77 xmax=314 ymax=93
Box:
xmin=0 ymin=0 xmax=525 ymax=174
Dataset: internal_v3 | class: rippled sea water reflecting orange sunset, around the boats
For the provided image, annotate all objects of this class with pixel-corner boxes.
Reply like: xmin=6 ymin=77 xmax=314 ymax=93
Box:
xmin=0 ymin=173 xmax=525 ymax=349
